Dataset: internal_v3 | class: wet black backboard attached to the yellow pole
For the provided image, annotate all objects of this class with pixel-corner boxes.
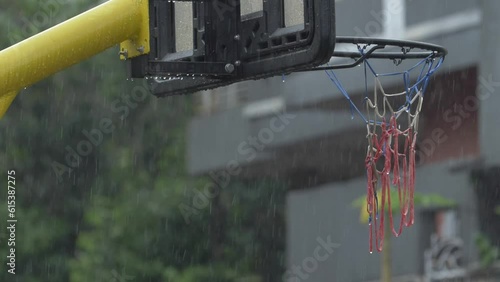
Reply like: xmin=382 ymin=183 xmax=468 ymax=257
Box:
xmin=125 ymin=0 xmax=335 ymax=96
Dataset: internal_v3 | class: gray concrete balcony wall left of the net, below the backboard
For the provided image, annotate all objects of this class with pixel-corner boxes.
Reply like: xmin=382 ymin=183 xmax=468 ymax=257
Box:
xmin=188 ymin=103 xmax=365 ymax=174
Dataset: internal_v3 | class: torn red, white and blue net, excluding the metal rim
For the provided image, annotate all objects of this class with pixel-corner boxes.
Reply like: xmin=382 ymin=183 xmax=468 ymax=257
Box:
xmin=326 ymin=46 xmax=443 ymax=253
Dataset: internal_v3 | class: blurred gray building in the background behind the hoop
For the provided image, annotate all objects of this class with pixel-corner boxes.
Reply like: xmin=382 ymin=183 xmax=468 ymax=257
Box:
xmin=188 ymin=0 xmax=500 ymax=281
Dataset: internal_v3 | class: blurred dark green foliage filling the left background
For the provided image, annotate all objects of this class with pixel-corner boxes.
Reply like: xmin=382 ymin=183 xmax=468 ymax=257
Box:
xmin=0 ymin=0 xmax=285 ymax=282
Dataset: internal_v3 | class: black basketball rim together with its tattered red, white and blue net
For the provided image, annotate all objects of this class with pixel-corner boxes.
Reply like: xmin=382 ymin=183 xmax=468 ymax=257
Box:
xmin=304 ymin=37 xmax=447 ymax=253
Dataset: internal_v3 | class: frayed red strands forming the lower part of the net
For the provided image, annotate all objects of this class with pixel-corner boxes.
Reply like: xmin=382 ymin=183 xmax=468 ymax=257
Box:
xmin=365 ymin=115 xmax=417 ymax=253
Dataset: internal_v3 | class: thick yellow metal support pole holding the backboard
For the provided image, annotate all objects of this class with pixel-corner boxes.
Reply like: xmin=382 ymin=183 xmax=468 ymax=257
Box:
xmin=0 ymin=0 xmax=149 ymax=118
